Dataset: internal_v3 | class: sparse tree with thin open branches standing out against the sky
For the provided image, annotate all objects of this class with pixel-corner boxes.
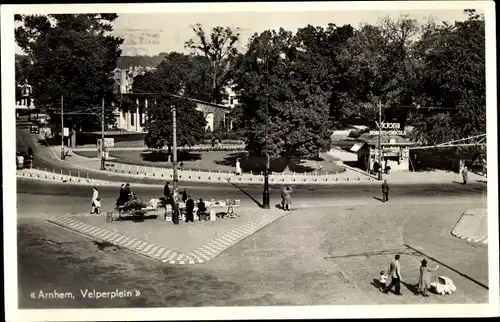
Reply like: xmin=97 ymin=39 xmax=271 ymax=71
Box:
xmin=185 ymin=24 xmax=240 ymax=104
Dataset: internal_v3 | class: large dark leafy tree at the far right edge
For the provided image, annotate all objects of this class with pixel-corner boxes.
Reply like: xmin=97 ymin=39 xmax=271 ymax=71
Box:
xmin=414 ymin=10 xmax=486 ymax=144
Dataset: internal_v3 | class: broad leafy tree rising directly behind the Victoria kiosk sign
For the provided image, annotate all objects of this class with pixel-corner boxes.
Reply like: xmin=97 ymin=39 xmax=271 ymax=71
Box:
xmin=338 ymin=16 xmax=420 ymax=126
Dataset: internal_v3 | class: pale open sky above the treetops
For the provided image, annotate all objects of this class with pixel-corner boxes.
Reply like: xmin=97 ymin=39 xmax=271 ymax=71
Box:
xmin=12 ymin=7 xmax=482 ymax=55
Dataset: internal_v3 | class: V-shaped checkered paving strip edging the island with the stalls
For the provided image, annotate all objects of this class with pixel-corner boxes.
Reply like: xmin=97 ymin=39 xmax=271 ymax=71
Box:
xmin=46 ymin=210 xmax=289 ymax=265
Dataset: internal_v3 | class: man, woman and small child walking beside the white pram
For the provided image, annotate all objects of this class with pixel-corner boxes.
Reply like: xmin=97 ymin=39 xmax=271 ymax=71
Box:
xmin=381 ymin=255 xmax=439 ymax=297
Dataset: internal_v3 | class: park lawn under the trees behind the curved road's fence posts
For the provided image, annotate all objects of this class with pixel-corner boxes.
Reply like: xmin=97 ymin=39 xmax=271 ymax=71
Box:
xmin=74 ymin=151 xmax=345 ymax=174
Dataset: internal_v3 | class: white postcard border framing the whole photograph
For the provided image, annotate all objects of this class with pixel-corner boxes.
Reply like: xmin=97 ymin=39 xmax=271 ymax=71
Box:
xmin=1 ymin=1 xmax=500 ymax=321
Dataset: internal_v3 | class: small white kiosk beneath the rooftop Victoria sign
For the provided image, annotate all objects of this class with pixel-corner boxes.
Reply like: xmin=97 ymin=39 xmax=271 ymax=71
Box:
xmin=351 ymin=133 xmax=414 ymax=171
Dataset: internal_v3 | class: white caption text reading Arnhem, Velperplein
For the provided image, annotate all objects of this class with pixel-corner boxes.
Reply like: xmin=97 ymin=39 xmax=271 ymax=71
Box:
xmin=30 ymin=289 xmax=141 ymax=300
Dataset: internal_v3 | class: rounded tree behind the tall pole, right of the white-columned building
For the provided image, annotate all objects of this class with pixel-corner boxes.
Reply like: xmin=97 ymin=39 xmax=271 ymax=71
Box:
xmin=134 ymin=52 xmax=207 ymax=149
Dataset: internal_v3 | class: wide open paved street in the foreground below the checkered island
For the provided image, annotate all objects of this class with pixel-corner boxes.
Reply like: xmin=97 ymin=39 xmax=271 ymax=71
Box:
xmin=18 ymin=192 xmax=488 ymax=308
